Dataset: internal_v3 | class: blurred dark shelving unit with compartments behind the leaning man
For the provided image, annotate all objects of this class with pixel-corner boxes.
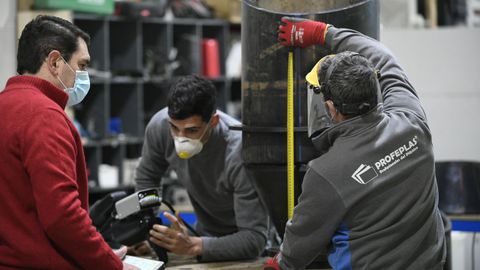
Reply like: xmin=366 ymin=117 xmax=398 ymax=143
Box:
xmin=73 ymin=13 xmax=241 ymax=198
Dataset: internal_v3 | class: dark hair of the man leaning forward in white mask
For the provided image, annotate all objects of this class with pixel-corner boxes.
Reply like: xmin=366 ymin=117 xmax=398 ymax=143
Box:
xmin=168 ymin=75 xmax=217 ymax=122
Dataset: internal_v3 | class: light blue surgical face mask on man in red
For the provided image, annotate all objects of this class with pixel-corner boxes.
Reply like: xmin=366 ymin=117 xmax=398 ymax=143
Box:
xmin=57 ymin=57 xmax=90 ymax=106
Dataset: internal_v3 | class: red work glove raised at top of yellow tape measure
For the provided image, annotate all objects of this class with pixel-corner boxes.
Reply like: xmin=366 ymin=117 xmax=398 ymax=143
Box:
xmin=278 ymin=17 xmax=327 ymax=48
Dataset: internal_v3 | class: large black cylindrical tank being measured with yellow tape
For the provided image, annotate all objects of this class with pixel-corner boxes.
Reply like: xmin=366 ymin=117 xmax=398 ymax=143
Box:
xmin=241 ymin=0 xmax=379 ymax=236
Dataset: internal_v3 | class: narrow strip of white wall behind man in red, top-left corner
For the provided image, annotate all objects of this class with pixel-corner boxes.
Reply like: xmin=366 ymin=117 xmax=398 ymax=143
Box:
xmin=0 ymin=0 xmax=17 ymax=91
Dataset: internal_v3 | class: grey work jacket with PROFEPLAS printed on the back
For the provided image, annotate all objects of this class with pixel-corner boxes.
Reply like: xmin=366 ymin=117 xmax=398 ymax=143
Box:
xmin=278 ymin=27 xmax=446 ymax=270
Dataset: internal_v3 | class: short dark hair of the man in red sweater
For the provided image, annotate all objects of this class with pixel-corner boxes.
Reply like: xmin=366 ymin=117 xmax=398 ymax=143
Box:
xmin=17 ymin=15 xmax=90 ymax=74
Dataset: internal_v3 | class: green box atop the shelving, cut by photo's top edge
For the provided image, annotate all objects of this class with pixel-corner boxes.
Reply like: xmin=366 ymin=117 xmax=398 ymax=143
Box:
xmin=35 ymin=0 xmax=114 ymax=15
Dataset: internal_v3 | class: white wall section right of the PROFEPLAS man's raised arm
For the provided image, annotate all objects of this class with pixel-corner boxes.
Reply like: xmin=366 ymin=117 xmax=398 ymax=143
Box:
xmin=380 ymin=28 xmax=480 ymax=161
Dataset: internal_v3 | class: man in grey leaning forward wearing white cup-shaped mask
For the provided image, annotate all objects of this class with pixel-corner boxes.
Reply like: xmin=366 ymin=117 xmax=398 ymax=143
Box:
xmin=135 ymin=75 xmax=267 ymax=261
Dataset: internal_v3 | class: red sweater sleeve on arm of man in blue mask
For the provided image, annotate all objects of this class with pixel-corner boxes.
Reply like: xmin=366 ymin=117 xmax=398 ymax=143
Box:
xmin=24 ymin=110 xmax=121 ymax=269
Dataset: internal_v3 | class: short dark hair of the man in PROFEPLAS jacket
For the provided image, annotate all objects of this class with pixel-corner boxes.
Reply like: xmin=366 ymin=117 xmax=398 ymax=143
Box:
xmin=318 ymin=52 xmax=380 ymax=117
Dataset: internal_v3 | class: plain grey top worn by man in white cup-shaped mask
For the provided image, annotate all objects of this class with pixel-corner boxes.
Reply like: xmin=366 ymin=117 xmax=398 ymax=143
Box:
xmin=135 ymin=108 xmax=267 ymax=261
